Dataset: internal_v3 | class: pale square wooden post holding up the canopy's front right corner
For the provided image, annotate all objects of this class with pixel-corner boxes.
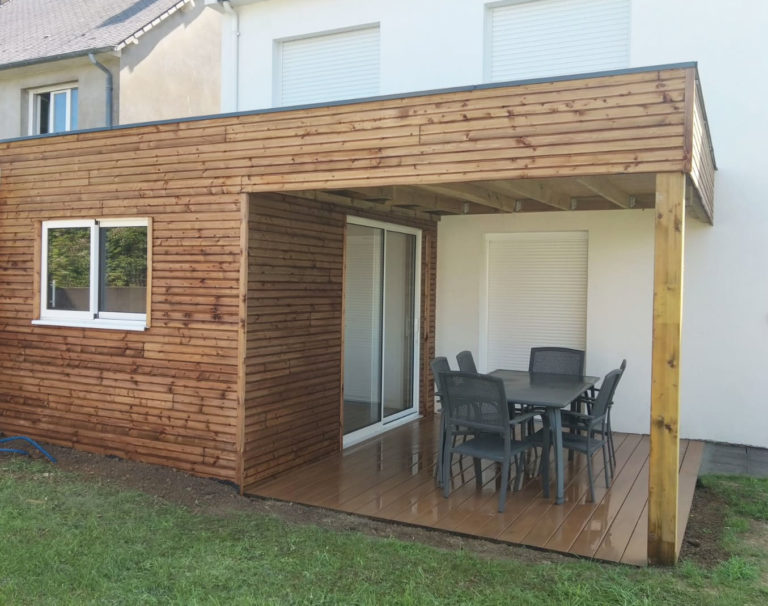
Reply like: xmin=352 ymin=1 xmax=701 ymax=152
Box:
xmin=648 ymin=173 xmax=686 ymax=565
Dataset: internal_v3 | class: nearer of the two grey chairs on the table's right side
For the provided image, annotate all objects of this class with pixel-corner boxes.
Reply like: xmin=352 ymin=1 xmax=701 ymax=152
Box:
xmin=562 ymin=368 xmax=623 ymax=503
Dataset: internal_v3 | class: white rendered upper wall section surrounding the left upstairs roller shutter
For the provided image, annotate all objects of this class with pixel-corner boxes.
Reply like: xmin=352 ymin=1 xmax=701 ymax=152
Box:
xmin=222 ymin=0 xmax=485 ymax=111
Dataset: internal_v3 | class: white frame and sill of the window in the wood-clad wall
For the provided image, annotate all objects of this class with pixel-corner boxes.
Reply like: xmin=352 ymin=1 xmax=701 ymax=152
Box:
xmin=32 ymin=218 xmax=151 ymax=330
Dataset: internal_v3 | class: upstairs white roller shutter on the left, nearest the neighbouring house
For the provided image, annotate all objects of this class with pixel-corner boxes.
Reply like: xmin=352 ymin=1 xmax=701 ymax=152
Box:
xmin=275 ymin=26 xmax=379 ymax=106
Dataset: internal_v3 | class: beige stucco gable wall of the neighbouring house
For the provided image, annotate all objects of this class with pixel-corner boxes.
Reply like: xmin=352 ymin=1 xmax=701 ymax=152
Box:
xmin=120 ymin=0 xmax=221 ymax=124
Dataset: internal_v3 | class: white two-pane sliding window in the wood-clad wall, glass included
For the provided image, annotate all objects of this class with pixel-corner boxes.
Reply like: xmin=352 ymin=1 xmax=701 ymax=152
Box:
xmin=36 ymin=219 xmax=149 ymax=330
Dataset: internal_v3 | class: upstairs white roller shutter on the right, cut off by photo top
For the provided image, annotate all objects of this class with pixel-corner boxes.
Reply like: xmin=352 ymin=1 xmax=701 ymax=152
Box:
xmin=486 ymin=0 xmax=631 ymax=82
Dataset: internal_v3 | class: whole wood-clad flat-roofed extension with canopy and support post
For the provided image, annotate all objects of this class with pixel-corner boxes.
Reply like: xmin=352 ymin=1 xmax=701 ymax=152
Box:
xmin=0 ymin=64 xmax=715 ymax=563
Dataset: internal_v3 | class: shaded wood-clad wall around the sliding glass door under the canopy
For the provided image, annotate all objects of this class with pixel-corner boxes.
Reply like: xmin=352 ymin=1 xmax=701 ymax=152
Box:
xmin=242 ymin=194 xmax=436 ymax=492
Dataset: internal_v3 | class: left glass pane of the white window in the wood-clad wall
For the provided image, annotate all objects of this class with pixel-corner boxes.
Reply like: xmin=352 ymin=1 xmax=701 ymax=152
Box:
xmin=46 ymin=227 xmax=91 ymax=311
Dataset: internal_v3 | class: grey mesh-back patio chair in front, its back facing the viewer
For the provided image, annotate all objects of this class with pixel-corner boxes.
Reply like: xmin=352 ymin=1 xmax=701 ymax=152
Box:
xmin=440 ymin=372 xmax=534 ymax=512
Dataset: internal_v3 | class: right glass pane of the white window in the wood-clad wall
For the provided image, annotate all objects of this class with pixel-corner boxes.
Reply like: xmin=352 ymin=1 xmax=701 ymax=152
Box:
xmin=99 ymin=226 xmax=147 ymax=313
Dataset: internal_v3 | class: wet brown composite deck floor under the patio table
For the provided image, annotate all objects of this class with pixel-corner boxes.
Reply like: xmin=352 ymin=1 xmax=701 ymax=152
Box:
xmin=247 ymin=419 xmax=703 ymax=566
